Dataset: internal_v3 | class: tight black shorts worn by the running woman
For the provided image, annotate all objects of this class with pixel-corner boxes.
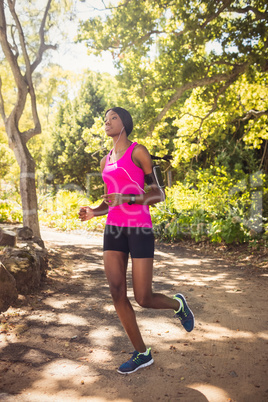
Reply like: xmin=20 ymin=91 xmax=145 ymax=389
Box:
xmin=103 ymin=225 xmax=154 ymax=258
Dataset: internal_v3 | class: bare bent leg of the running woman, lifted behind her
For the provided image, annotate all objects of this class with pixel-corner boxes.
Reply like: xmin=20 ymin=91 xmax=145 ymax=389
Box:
xmin=132 ymin=258 xmax=180 ymax=311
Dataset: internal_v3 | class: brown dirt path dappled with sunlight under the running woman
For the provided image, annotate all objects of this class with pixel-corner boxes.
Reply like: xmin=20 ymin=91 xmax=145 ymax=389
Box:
xmin=0 ymin=231 xmax=268 ymax=402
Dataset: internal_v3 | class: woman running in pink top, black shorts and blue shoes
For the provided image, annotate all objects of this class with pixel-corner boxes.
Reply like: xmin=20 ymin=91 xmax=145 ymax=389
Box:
xmin=79 ymin=107 xmax=194 ymax=374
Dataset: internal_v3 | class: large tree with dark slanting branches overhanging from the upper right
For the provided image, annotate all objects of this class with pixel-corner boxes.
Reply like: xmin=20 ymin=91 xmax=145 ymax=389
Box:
xmin=78 ymin=0 xmax=268 ymax=170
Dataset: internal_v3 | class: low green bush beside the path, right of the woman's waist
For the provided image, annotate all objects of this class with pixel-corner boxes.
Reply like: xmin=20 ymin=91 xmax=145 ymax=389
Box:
xmin=152 ymin=167 xmax=268 ymax=244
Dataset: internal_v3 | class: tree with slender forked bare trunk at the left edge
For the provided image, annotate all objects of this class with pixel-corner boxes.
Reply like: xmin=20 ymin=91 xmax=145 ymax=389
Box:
xmin=0 ymin=0 xmax=71 ymax=237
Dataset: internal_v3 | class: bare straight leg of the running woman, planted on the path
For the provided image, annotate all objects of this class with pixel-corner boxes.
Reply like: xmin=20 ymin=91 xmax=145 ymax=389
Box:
xmin=103 ymin=250 xmax=146 ymax=353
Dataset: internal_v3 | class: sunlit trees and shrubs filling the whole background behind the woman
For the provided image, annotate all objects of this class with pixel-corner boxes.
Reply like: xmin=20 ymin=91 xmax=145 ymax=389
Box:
xmin=0 ymin=0 xmax=268 ymax=245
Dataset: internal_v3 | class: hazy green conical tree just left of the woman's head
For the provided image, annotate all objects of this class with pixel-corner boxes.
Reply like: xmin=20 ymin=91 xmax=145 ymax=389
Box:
xmin=43 ymin=71 xmax=116 ymax=195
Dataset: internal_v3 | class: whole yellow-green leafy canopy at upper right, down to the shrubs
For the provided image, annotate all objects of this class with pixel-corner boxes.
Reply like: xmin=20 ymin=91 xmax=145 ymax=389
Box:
xmin=78 ymin=0 xmax=268 ymax=174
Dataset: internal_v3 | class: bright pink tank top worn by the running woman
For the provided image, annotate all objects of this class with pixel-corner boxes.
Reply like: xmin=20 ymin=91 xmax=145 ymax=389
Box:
xmin=102 ymin=142 xmax=152 ymax=228
